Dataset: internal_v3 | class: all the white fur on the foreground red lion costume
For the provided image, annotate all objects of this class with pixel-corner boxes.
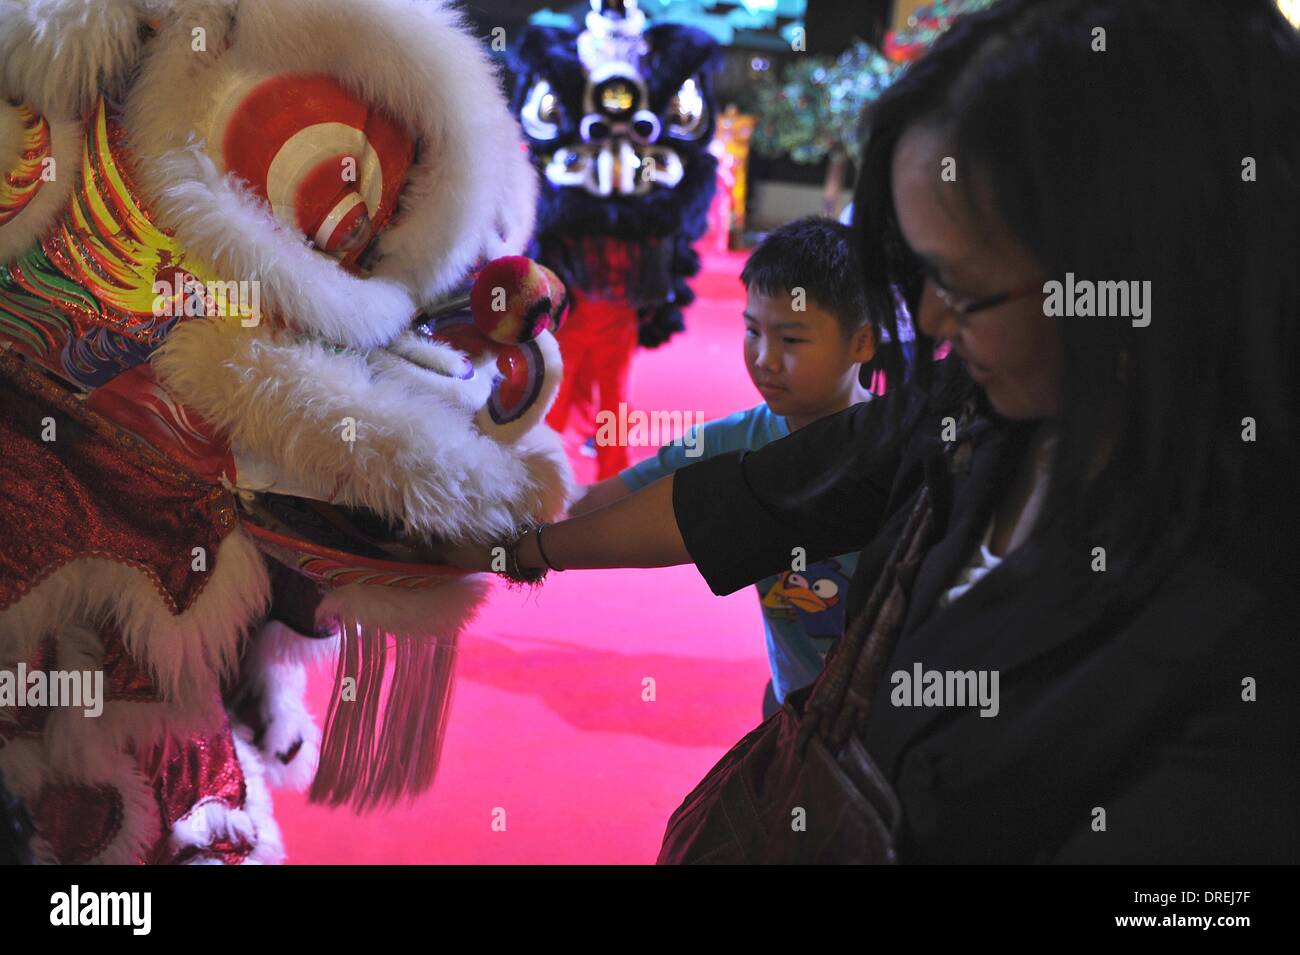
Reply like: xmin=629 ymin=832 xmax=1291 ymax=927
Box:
xmin=0 ymin=0 xmax=573 ymax=863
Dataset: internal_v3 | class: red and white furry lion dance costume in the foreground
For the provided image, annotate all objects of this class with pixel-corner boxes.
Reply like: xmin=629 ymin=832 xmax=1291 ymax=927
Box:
xmin=0 ymin=0 xmax=571 ymax=863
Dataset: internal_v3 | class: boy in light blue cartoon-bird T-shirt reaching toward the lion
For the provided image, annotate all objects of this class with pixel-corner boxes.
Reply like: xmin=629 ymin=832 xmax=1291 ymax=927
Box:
xmin=569 ymin=217 xmax=875 ymax=716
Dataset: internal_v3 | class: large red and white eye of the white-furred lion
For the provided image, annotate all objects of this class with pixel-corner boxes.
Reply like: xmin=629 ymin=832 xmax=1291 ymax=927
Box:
xmin=209 ymin=74 xmax=415 ymax=265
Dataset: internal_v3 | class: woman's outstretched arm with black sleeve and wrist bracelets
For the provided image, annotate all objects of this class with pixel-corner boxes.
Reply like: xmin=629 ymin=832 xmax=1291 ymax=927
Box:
xmin=433 ymin=389 xmax=915 ymax=594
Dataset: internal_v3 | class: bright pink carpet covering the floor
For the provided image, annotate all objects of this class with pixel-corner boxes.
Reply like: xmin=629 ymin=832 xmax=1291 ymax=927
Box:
xmin=274 ymin=253 xmax=767 ymax=864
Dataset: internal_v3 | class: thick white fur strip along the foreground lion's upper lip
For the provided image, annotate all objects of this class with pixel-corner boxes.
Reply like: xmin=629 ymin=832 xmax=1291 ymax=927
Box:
xmin=153 ymin=320 xmax=568 ymax=540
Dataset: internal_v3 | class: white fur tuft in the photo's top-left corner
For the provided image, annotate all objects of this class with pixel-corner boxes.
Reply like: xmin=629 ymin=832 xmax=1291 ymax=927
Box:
xmin=0 ymin=0 xmax=144 ymax=120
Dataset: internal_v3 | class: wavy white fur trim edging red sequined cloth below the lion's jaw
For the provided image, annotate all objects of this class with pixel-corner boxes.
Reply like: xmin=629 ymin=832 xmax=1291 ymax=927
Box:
xmin=0 ymin=530 xmax=270 ymax=700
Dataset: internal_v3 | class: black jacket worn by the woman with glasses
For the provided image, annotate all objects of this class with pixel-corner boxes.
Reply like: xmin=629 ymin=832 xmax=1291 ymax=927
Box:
xmin=673 ymin=363 xmax=1300 ymax=863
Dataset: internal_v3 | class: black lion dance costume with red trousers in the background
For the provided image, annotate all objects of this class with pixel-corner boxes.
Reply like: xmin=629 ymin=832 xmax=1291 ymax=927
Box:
xmin=510 ymin=0 xmax=719 ymax=479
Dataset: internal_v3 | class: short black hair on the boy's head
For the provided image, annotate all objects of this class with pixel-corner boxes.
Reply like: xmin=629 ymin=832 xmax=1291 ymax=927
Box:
xmin=740 ymin=216 xmax=867 ymax=340
